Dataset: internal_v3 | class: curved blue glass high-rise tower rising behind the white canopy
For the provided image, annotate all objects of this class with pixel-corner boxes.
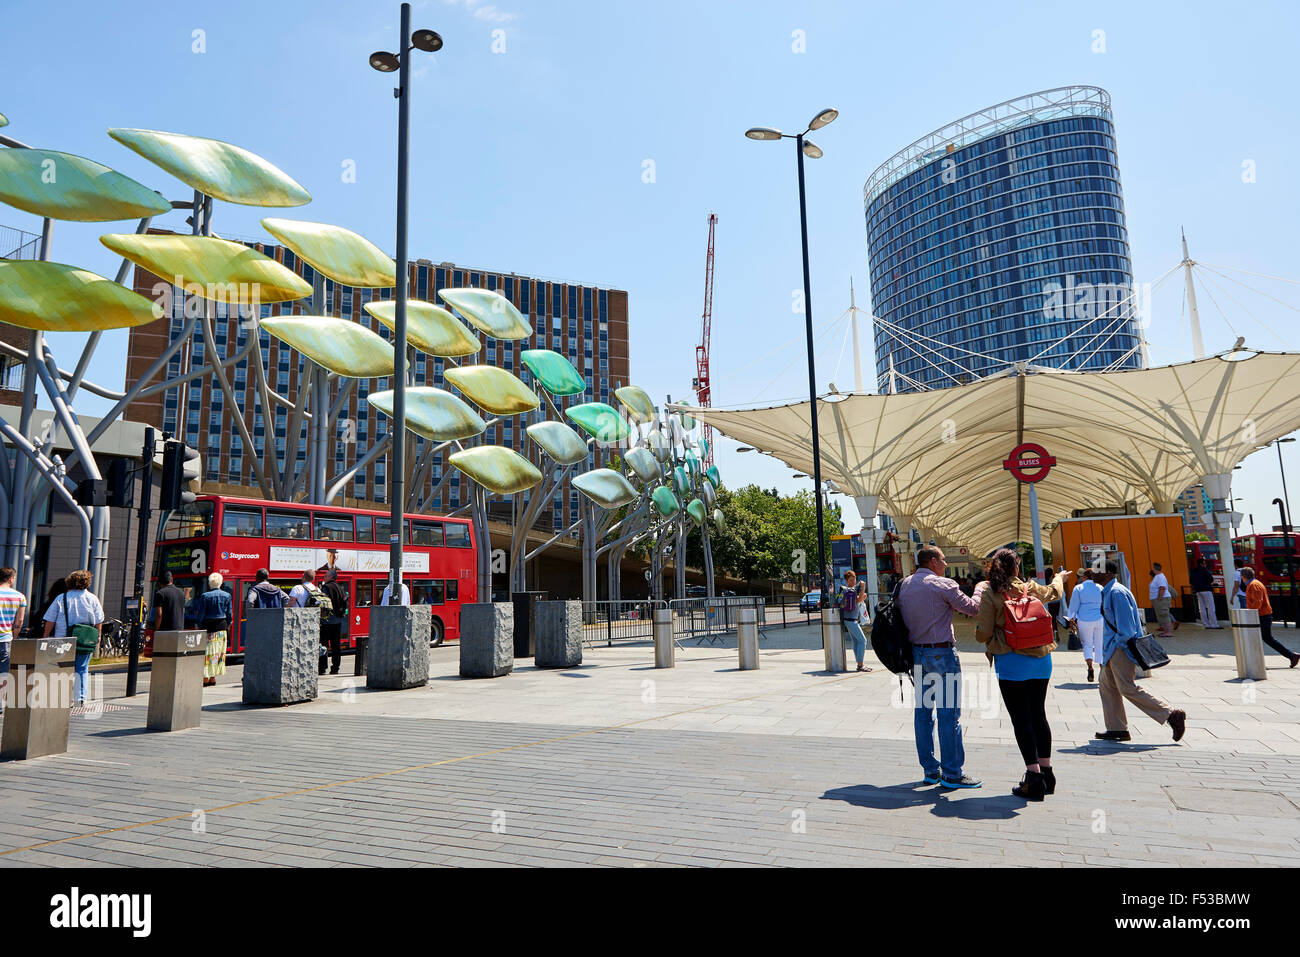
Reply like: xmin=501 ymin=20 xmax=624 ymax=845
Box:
xmin=865 ymin=87 xmax=1143 ymax=391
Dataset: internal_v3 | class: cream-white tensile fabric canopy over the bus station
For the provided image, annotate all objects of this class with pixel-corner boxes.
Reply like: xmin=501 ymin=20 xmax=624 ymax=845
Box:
xmin=672 ymin=352 xmax=1300 ymax=566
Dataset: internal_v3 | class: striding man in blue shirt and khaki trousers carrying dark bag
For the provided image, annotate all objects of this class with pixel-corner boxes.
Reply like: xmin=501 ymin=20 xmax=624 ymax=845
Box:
xmin=1093 ymin=562 xmax=1187 ymax=741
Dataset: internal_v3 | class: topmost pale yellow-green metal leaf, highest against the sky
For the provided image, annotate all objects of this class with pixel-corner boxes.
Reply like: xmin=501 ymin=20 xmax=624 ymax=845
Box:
xmin=108 ymin=130 xmax=312 ymax=205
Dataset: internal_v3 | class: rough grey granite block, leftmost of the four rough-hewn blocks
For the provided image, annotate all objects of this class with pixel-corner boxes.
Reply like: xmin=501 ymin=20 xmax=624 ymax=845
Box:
xmin=243 ymin=607 xmax=321 ymax=705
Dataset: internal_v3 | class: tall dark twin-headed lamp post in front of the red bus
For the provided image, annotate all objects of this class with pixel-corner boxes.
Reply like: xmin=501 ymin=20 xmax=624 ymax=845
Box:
xmin=371 ymin=4 xmax=442 ymax=605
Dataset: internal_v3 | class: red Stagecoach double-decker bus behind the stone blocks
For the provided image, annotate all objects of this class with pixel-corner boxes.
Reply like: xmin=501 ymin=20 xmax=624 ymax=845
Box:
xmin=153 ymin=495 xmax=478 ymax=654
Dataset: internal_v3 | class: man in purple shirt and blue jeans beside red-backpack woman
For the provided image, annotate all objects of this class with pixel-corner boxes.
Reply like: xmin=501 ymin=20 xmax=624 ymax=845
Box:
xmin=898 ymin=545 xmax=980 ymax=788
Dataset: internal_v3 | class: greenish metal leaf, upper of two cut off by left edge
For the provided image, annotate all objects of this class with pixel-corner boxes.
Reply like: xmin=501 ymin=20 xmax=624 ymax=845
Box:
xmin=0 ymin=150 xmax=172 ymax=222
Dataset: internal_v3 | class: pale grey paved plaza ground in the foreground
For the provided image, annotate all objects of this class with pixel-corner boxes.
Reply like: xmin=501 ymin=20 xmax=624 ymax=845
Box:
xmin=0 ymin=625 xmax=1300 ymax=867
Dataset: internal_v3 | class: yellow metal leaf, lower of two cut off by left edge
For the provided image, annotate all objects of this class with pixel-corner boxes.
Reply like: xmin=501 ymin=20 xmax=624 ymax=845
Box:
xmin=0 ymin=260 xmax=159 ymax=333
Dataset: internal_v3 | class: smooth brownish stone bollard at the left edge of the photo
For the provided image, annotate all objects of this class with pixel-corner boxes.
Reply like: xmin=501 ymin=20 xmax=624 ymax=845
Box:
xmin=0 ymin=638 xmax=77 ymax=761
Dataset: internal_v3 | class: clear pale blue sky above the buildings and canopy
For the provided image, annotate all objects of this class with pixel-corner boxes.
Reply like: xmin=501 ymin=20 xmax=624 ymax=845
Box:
xmin=0 ymin=0 xmax=1300 ymax=538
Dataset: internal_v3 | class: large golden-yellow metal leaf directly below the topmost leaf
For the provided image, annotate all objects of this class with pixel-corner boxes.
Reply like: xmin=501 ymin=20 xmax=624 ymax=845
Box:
xmin=99 ymin=233 xmax=312 ymax=306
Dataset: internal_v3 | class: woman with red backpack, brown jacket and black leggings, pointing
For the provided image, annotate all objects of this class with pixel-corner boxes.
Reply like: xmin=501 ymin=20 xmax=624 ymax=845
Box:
xmin=975 ymin=549 xmax=1070 ymax=801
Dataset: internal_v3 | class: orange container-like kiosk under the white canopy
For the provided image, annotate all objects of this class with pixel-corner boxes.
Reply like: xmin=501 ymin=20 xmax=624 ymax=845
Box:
xmin=1052 ymin=515 xmax=1191 ymax=609
